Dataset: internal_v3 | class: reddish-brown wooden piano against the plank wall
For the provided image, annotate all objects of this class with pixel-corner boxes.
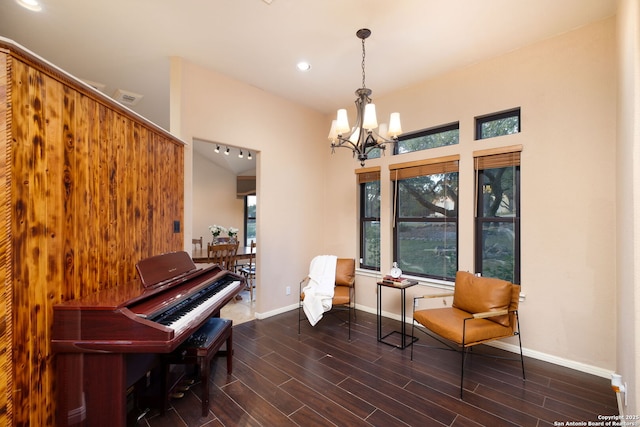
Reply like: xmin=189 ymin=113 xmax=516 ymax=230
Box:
xmin=51 ymin=252 xmax=245 ymax=427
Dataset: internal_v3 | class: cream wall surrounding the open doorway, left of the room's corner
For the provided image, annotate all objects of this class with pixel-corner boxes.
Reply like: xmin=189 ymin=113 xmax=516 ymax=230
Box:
xmin=171 ymin=58 xmax=326 ymax=317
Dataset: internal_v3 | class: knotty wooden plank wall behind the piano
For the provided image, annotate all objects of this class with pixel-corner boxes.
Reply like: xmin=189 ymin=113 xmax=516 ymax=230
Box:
xmin=0 ymin=45 xmax=184 ymax=426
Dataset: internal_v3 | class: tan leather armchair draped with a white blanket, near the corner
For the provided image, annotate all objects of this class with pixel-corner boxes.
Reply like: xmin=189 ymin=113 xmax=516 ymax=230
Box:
xmin=298 ymin=258 xmax=356 ymax=341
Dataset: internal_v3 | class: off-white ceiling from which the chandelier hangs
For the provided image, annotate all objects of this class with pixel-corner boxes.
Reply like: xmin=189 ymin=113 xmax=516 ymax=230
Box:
xmin=0 ymin=0 xmax=616 ymax=138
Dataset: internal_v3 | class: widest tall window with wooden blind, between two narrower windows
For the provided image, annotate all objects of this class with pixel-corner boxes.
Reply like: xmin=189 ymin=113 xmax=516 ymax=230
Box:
xmin=390 ymin=155 xmax=459 ymax=280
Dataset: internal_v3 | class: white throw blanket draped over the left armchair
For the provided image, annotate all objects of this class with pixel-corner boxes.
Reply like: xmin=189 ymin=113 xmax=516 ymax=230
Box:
xmin=302 ymin=255 xmax=338 ymax=326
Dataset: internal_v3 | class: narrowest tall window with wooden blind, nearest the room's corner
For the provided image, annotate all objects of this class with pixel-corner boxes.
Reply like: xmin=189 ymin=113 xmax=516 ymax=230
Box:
xmin=356 ymin=167 xmax=380 ymax=270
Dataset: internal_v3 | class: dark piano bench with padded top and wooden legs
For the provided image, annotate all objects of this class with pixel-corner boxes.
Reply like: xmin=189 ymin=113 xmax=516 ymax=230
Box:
xmin=162 ymin=317 xmax=233 ymax=417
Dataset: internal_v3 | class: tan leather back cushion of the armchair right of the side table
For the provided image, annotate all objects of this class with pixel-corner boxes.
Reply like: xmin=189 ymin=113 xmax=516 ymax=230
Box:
xmin=452 ymin=271 xmax=512 ymax=326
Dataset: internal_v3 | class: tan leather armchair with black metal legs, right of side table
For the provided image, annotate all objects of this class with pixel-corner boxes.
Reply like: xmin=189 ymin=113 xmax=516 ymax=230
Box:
xmin=411 ymin=271 xmax=525 ymax=398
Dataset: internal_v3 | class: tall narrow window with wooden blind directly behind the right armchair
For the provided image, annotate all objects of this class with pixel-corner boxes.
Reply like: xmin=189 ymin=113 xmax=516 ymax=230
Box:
xmin=474 ymin=146 xmax=521 ymax=283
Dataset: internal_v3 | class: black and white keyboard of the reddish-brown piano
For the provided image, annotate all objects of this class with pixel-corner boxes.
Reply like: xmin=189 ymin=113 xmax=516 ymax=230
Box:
xmin=149 ymin=280 xmax=240 ymax=335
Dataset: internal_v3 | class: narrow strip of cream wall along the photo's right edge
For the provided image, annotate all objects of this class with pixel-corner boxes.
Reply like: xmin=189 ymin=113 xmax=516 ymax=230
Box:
xmin=616 ymin=0 xmax=640 ymax=414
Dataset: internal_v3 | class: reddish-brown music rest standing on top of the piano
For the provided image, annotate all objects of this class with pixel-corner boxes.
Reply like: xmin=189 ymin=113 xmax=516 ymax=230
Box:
xmin=136 ymin=251 xmax=196 ymax=288
